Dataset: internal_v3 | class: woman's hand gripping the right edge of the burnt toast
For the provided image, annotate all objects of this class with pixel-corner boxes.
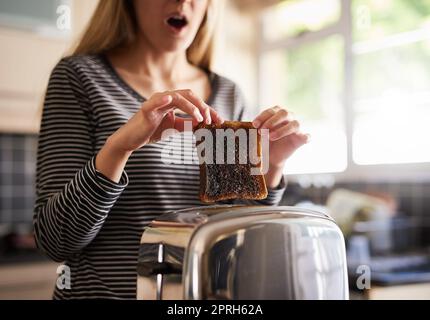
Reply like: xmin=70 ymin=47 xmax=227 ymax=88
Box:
xmin=252 ymin=106 xmax=310 ymax=185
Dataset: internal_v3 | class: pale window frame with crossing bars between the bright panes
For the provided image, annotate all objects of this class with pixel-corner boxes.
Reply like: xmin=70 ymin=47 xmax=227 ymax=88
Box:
xmin=256 ymin=0 xmax=430 ymax=182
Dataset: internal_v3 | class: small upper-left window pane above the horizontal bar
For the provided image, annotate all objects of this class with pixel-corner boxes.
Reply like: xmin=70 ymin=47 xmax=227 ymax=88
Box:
xmin=263 ymin=0 xmax=340 ymax=41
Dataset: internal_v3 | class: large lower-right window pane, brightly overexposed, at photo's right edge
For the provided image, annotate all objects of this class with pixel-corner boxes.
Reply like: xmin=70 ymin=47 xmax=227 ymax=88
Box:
xmin=353 ymin=40 xmax=430 ymax=164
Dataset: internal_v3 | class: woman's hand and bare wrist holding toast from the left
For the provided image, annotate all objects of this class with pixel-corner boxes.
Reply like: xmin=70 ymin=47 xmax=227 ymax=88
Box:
xmin=96 ymin=90 xmax=224 ymax=182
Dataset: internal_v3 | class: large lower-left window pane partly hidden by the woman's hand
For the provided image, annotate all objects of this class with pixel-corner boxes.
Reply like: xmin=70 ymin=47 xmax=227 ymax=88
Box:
xmin=261 ymin=36 xmax=347 ymax=173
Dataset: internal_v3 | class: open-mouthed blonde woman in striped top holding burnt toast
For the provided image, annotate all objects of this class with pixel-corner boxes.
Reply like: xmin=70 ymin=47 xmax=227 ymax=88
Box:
xmin=34 ymin=0 xmax=307 ymax=299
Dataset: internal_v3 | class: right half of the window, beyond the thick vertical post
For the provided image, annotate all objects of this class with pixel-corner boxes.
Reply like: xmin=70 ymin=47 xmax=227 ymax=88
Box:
xmin=352 ymin=0 xmax=430 ymax=164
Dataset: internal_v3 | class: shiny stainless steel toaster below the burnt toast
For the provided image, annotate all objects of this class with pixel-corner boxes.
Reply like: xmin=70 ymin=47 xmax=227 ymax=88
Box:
xmin=137 ymin=205 xmax=348 ymax=300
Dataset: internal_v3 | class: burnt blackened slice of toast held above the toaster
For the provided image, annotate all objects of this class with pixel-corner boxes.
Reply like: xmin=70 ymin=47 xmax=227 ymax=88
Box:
xmin=194 ymin=121 xmax=267 ymax=202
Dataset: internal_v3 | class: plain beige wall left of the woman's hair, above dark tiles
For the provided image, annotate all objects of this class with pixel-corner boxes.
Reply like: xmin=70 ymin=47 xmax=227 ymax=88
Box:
xmin=0 ymin=0 xmax=97 ymax=132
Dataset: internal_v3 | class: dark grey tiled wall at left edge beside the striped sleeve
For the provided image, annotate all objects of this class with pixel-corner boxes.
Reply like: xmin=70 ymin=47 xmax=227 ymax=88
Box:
xmin=0 ymin=134 xmax=37 ymax=224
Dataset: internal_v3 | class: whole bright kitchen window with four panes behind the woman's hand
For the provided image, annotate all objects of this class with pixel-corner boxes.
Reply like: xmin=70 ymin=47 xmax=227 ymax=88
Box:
xmin=259 ymin=0 xmax=430 ymax=174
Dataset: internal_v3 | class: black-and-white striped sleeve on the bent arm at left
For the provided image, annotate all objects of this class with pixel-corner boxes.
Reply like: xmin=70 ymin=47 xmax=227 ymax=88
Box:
xmin=33 ymin=59 xmax=128 ymax=261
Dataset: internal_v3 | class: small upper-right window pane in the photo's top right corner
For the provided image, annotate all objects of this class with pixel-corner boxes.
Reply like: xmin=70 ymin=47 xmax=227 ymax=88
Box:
xmin=352 ymin=0 xmax=430 ymax=41
